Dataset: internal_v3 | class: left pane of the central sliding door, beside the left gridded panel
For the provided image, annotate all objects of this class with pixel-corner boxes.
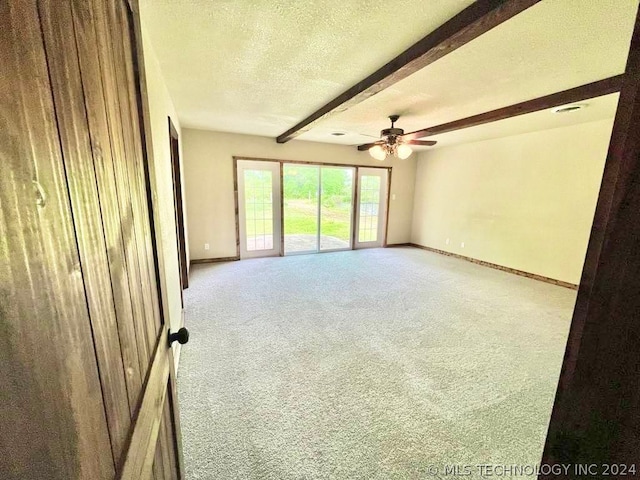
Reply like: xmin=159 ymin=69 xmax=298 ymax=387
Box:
xmin=282 ymin=163 xmax=320 ymax=255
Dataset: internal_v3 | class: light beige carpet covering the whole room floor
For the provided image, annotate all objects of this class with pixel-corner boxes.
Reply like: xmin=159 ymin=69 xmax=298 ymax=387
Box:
xmin=178 ymin=247 xmax=576 ymax=480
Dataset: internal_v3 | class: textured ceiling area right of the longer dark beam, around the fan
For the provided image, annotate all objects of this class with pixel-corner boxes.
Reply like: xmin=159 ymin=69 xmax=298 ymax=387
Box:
xmin=299 ymin=0 xmax=638 ymax=143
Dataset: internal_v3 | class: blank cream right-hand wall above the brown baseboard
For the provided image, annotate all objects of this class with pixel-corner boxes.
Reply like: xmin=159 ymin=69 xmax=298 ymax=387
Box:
xmin=411 ymin=119 xmax=613 ymax=284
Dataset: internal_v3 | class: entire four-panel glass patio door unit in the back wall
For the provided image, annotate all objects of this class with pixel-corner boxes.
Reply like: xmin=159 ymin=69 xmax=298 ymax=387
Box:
xmin=236 ymin=159 xmax=389 ymax=258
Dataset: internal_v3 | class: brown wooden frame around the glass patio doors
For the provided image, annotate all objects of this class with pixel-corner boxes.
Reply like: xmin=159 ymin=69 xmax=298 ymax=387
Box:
xmin=231 ymin=155 xmax=393 ymax=255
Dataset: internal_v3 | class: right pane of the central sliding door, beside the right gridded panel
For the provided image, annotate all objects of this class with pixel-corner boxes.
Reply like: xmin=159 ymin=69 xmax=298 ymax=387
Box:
xmin=320 ymin=167 xmax=354 ymax=250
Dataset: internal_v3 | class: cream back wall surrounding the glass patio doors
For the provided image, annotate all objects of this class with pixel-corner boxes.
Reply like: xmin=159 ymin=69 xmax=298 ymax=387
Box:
xmin=182 ymin=128 xmax=416 ymax=259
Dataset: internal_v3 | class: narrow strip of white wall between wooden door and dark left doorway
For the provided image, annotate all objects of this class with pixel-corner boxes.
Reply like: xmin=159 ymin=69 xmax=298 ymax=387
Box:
xmin=142 ymin=24 xmax=186 ymax=365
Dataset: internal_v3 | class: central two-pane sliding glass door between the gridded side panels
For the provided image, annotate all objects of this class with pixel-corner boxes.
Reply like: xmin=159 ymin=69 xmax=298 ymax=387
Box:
xmin=282 ymin=163 xmax=355 ymax=255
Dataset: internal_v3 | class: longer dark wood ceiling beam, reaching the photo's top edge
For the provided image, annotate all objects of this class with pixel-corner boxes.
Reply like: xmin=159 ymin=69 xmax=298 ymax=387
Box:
xmin=276 ymin=0 xmax=540 ymax=143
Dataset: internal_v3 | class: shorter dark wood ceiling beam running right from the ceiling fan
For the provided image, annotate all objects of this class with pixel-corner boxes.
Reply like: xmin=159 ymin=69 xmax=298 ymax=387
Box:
xmin=403 ymin=75 xmax=624 ymax=140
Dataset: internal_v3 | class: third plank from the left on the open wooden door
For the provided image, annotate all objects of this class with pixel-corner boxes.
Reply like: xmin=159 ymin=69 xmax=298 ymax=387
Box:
xmin=72 ymin=0 xmax=142 ymax=420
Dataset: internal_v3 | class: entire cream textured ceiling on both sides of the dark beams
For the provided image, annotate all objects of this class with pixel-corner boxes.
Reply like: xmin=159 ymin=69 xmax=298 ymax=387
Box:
xmin=141 ymin=0 xmax=638 ymax=148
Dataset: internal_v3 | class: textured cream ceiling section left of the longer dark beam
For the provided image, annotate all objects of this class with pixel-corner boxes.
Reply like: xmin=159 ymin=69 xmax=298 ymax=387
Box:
xmin=140 ymin=0 xmax=473 ymax=133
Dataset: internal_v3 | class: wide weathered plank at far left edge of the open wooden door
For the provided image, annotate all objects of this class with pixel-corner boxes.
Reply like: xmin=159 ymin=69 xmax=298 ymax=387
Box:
xmin=0 ymin=0 xmax=114 ymax=480
